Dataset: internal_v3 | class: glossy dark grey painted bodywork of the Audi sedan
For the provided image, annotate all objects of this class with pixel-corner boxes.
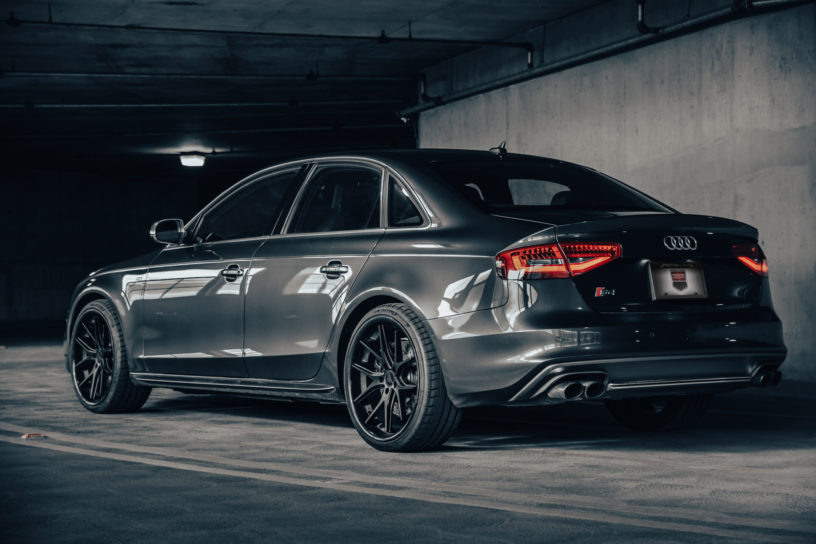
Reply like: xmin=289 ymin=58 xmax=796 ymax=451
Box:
xmin=63 ymin=151 xmax=786 ymax=406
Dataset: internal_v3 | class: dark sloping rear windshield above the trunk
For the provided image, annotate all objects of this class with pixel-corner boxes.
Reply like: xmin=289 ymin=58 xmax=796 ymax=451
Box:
xmin=428 ymin=157 xmax=671 ymax=213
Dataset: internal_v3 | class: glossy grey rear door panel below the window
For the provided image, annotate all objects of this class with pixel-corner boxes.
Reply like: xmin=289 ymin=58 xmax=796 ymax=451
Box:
xmin=245 ymin=229 xmax=383 ymax=380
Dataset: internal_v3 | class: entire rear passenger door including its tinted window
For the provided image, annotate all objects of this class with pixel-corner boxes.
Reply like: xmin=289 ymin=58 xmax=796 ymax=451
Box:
xmin=245 ymin=161 xmax=384 ymax=380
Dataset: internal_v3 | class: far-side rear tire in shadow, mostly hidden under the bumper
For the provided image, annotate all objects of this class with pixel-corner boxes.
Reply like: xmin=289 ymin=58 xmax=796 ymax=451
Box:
xmin=606 ymin=395 xmax=711 ymax=431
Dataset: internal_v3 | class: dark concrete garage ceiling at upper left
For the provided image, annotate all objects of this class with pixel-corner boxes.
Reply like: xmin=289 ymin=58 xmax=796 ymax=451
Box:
xmin=0 ymin=0 xmax=598 ymax=157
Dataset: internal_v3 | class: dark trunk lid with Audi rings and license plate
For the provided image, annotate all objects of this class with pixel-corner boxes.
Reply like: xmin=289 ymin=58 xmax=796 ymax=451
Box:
xmin=520 ymin=212 xmax=763 ymax=312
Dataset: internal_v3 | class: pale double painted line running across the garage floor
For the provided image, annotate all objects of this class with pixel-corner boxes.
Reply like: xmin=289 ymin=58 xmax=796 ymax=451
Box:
xmin=0 ymin=425 xmax=808 ymax=541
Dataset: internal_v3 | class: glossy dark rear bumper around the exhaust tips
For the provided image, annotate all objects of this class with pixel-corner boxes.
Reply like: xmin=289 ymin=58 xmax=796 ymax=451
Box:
xmin=429 ymin=309 xmax=787 ymax=407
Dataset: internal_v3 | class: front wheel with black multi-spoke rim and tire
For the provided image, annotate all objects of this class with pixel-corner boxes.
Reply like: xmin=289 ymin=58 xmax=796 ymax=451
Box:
xmin=68 ymin=299 xmax=150 ymax=414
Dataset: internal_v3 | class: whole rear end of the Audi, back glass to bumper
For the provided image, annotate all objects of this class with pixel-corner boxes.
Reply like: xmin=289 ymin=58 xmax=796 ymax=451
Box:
xmin=414 ymin=156 xmax=786 ymax=406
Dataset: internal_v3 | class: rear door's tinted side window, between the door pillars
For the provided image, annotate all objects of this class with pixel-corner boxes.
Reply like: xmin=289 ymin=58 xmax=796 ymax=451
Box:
xmin=289 ymin=165 xmax=382 ymax=232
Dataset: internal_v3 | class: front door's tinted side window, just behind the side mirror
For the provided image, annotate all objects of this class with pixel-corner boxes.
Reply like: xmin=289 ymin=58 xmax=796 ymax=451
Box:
xmin=196 ymin=168 xmax=300 ymax=242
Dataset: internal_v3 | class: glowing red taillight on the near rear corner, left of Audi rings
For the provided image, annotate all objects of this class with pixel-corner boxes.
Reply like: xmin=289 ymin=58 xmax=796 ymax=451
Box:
xmin=496 ymin=242 xmax=621 ymax=280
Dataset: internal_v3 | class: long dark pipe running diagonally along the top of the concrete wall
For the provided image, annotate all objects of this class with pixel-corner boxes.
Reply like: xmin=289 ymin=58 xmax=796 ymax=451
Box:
xmin=397 ymin=0 xmax=813 ymax=118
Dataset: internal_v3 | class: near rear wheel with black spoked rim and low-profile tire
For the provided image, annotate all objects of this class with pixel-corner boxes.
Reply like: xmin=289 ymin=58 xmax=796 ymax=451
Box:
xmin=343 ymin=304 xmax=462 ymax=451
